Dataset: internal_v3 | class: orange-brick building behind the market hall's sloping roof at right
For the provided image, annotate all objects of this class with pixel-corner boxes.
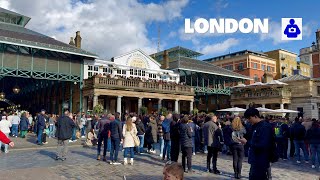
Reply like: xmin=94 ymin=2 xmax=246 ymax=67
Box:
xmin=204 ymin=50 xmax=277 ymax=84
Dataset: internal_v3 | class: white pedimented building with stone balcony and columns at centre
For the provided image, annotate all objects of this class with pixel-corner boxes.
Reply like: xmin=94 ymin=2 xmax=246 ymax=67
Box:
xmin=83 ymin=49 xmax=194 ymax=113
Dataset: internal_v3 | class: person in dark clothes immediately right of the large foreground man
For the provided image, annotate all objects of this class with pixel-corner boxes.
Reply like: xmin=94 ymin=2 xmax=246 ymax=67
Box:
xmin=274 ymin=119 xmax=289 ymax=160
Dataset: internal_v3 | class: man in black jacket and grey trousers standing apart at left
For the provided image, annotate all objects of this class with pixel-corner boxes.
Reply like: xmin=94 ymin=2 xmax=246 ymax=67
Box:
xmin=56 ymin=110 xmax=76 ymax=161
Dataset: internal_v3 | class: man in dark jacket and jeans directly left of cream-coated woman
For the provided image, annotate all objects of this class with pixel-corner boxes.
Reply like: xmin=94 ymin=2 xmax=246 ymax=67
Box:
xmin=109 ymin=116 xmax=123 ymax=165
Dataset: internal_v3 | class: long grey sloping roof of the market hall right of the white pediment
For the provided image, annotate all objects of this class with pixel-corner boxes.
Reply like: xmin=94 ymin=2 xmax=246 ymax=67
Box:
xmin=169 ymin=57 xmax=251 ymax=80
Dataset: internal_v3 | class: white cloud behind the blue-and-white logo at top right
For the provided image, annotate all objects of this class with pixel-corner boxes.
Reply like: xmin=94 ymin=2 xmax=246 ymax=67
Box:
xmin=259 ymin=21 xmax=313 ymax=45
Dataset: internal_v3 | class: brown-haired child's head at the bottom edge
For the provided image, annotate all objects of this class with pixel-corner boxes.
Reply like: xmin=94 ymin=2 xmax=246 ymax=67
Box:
xmin=163 ymin=161 xmax=183 ymax=180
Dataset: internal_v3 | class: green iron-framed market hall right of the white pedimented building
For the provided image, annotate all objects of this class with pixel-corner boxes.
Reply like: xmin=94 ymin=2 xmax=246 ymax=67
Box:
xmin=150 ymin=46 xmax=251 ymax=112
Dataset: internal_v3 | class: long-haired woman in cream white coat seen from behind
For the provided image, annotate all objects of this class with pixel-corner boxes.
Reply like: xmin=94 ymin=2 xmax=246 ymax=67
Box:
xmin=122 ymin=117 xmax=138 ymax=165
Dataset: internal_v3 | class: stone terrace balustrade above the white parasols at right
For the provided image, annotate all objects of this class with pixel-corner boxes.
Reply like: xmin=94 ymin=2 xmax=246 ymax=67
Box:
xmin=231 ymin=90 xmax=291 ymax=99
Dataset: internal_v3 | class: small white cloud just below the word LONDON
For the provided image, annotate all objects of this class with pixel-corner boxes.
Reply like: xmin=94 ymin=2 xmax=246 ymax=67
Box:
xmin=200 ymin=38 xmax=240 ymax=55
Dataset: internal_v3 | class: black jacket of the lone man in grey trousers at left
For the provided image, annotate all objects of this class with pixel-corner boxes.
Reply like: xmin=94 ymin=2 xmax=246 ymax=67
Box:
xmin=56 ymin=116 xmax=76 ymax=140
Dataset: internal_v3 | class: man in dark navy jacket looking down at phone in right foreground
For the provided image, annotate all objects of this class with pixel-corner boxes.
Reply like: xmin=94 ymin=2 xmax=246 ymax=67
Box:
xmin=244 ymin=107 xmax=277 ymax=180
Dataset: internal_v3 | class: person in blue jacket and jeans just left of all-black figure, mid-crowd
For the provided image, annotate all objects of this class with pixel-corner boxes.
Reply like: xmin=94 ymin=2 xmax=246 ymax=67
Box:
xmin=162 ymin=113 xmax=172 ymax=161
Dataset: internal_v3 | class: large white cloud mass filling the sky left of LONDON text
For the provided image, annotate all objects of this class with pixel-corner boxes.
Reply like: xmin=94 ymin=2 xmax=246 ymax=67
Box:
xmin=0 ymin=0 xmax=189 ymax=58
